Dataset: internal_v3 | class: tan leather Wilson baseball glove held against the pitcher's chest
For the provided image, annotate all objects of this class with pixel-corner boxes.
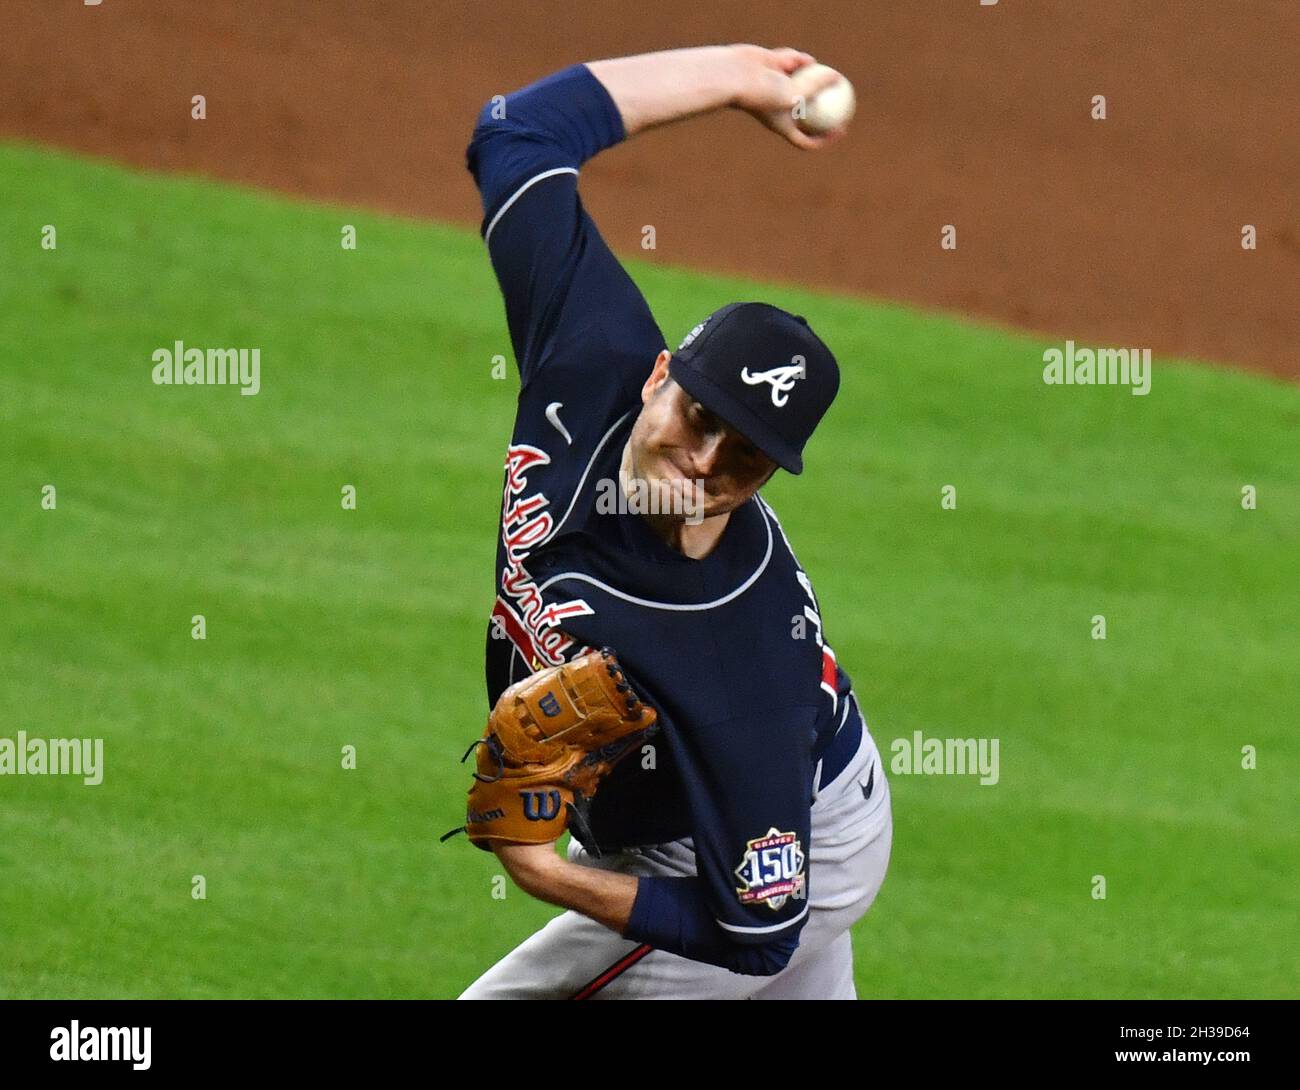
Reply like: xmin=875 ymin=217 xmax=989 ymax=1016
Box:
xmin=442 ymin=648 xmax=658 ymax=852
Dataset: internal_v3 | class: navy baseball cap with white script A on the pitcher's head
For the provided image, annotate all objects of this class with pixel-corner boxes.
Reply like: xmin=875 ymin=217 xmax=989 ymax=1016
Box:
xmin=668 ymin=303 xmax=840 ymax=473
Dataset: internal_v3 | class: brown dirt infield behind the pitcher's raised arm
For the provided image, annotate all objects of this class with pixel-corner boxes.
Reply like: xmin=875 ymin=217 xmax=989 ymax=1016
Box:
xmin=0 ymin=0 xmax=1300 ymax=377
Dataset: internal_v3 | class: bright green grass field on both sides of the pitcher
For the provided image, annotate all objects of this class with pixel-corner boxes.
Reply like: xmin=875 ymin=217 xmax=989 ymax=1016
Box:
xmin=0 ymin=146 xmax=1300 ymax=998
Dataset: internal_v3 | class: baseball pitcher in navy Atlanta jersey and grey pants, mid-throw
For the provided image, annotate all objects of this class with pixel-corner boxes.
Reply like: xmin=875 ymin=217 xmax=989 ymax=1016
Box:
xmin=462 ymin=46 xmax=893 ymax=999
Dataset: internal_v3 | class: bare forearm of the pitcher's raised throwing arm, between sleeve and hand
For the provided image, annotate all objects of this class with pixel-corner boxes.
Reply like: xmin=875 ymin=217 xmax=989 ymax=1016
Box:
xmin=586 ymin=46 xmax=754 ymax=137
